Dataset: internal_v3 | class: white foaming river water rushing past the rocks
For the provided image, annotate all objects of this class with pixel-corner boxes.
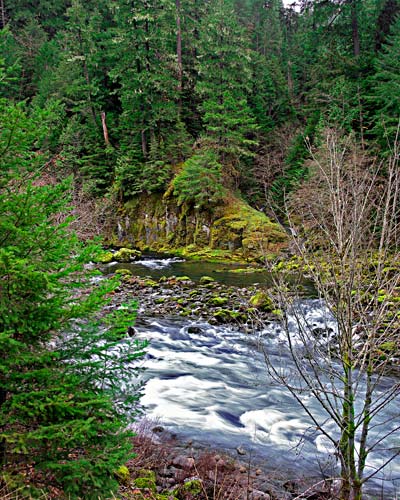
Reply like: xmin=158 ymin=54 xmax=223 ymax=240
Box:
xmin=119 ymin=259 xmax=400 ymax=500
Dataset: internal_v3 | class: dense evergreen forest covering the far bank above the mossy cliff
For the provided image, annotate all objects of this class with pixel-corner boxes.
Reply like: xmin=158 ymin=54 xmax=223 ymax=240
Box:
xmin=1 ymin=0 xmax=400 ymax=213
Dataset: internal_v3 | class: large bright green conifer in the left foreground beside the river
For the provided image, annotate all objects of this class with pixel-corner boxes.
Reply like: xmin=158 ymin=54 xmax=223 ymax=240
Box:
xmin=0 ymin=92 xmax=143 ymax=499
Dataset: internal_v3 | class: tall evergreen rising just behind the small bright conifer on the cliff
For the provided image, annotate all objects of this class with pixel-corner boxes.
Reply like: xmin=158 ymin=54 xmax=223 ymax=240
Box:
xmin=196 ymin=0 xmax=256 ymax=177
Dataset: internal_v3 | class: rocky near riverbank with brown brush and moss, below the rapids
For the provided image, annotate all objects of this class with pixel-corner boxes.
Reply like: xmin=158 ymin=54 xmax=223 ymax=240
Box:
xmin=118 ymin=420 xmax=337 ymax=500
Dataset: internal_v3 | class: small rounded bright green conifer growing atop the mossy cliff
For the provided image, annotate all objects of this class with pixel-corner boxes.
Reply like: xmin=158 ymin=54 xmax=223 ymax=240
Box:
xmin=173 ymin=151 xmax=225 ymax=208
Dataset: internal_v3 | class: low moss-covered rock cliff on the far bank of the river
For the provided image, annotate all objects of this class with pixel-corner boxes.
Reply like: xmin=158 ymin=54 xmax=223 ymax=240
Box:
xmin=110 ymin=194 xmax=286 ymax=260
